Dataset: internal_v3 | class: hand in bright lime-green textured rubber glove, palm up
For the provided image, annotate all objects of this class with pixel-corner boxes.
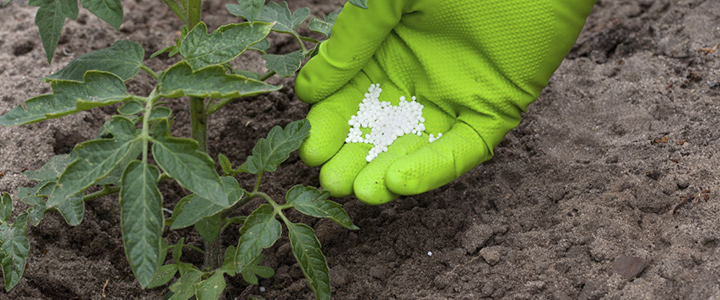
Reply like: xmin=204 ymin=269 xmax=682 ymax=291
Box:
xmin=295 ymin=0 xmax=595 ymax=204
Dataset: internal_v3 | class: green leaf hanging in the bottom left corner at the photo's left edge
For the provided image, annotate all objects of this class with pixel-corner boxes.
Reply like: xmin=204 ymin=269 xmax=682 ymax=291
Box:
xmin=0 ymin=214 xmax=30 ymax=291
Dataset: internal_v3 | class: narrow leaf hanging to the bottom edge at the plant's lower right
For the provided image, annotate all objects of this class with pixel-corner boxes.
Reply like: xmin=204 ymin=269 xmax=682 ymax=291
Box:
xmin=286 ymin=223 xmax=330 ymax=300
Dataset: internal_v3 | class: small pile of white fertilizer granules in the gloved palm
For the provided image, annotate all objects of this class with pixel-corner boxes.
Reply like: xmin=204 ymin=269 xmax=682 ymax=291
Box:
xmin=345 ymin=83 xmax=442 ymax=162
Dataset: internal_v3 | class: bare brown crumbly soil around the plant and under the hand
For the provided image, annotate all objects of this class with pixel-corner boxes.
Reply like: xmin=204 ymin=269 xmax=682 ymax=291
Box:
xmin=0 ymin=0 xmax=720 ymax=299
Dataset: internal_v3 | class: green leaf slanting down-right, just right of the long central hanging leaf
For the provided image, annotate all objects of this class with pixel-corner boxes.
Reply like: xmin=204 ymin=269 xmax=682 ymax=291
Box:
xmin=152 ymin=125 xmax=228 ymax=207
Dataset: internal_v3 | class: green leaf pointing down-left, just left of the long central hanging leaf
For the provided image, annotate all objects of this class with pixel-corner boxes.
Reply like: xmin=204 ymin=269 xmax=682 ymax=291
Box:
xmin=47 ymin=118 xmax=142 ymax=207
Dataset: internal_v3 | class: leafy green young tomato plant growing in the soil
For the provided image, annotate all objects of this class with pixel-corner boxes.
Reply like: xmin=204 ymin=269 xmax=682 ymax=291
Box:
xmin=0 ymin=0 xmax=364 ymax=300
